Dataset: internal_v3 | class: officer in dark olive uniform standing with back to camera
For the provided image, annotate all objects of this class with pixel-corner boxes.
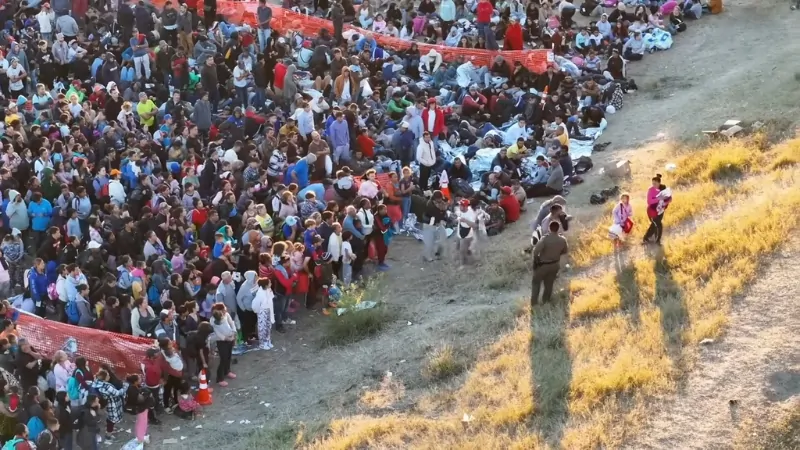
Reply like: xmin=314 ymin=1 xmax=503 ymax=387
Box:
xmin=531 ymin=221 xmax=569 ymax=307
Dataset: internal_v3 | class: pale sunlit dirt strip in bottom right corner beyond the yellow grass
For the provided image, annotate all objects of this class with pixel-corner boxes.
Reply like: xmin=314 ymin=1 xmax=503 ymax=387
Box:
xmin=629 ymin=242 xmax=800 ymax=449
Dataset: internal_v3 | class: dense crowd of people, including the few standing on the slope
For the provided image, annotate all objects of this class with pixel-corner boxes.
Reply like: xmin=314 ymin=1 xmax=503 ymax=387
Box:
xmin=0 ymin=0 xmax=702 ymax=450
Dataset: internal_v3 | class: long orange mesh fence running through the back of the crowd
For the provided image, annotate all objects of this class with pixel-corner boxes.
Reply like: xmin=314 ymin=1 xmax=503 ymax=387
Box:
xmin=153 ymin=0 xmax=553 ymax=73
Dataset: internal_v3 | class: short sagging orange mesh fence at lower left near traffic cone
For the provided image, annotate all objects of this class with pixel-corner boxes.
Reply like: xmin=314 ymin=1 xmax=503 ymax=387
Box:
xmin=17 ymin=313 xmax=153 ymax=377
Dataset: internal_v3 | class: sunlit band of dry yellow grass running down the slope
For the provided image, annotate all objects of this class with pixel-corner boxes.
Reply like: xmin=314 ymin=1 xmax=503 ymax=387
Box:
xmin=296 ymin=142 xmax=800 ymax=450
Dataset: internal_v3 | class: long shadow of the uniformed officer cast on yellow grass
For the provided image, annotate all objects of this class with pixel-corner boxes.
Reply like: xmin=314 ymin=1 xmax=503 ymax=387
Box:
xmin=531 ymin=290 xmax=572 ymax=447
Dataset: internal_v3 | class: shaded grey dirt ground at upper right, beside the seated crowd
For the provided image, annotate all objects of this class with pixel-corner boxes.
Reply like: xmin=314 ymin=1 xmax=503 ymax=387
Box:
xmin=593 ymin=0 xmax=800 ymax=158
